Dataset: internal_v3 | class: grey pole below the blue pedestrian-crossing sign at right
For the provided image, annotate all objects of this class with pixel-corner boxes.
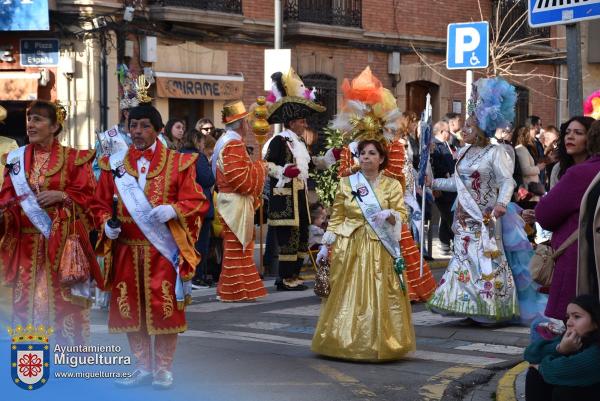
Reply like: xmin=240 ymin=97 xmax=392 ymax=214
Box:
xmin=566 ymin=24 xmax=583 ymax=118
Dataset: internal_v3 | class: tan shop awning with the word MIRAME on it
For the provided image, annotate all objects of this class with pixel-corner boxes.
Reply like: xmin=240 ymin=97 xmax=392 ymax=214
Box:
xmin=154 ymin=72 xmax=244 ymax=100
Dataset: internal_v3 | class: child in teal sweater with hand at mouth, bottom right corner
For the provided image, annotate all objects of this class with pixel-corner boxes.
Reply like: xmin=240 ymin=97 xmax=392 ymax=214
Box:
xmin=524 ymin=295 xmax=600 ymax=401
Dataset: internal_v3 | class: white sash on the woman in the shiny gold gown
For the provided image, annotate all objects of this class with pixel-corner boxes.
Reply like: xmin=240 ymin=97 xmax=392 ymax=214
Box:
xmin=348 ymin=172 xmax=406 ymax=290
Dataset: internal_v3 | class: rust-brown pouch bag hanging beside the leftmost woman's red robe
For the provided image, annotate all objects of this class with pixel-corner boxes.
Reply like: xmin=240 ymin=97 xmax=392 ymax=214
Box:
xmin=58 ymin=206 xmax=90 ymax=287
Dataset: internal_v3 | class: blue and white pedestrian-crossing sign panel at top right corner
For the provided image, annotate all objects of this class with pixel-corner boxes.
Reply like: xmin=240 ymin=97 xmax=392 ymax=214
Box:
xmin=528 ymin=0 xmax=600 ymax=28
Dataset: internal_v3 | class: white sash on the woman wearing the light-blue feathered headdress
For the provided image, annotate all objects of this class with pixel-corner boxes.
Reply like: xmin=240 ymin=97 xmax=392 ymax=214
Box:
xmin=454 ymin=152 xmax=498 ymax=275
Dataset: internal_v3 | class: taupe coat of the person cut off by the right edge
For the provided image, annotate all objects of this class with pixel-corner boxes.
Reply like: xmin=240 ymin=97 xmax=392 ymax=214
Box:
xmin=577 ymin=173 xmax=600 ymax=295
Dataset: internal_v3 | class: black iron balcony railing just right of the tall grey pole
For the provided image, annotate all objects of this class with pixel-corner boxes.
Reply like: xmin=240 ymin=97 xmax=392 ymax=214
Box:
xmin=284 ymin=0 xmax=362 ymax=28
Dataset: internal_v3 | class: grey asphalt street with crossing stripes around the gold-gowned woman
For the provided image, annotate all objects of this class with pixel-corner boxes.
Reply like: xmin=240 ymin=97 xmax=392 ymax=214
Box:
xmin=83 ymin=269 xmax=528 ymax=401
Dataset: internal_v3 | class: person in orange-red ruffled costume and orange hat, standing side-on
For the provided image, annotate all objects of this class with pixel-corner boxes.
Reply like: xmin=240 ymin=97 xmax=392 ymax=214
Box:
xmin=212 ymin=101 xmax=267 ymax=302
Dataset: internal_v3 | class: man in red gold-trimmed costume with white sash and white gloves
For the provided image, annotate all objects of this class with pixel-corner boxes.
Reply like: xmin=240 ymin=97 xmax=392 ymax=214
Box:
xmin=93 ymin=105 xmax=208 ymax=388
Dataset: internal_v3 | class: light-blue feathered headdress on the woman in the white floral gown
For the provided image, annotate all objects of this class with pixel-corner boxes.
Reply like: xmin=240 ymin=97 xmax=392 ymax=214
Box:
xmin=467 ymin=77 xmax=517 ymax=138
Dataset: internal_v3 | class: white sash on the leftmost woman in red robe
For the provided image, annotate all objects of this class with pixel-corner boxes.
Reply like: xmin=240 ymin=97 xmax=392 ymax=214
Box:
xmin=6 ymin=146 xmax=52 ymax=239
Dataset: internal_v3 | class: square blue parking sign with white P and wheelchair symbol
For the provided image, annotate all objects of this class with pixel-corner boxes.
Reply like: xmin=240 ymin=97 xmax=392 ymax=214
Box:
xmin=446 ymin=21 xmax=490 ymax=70
